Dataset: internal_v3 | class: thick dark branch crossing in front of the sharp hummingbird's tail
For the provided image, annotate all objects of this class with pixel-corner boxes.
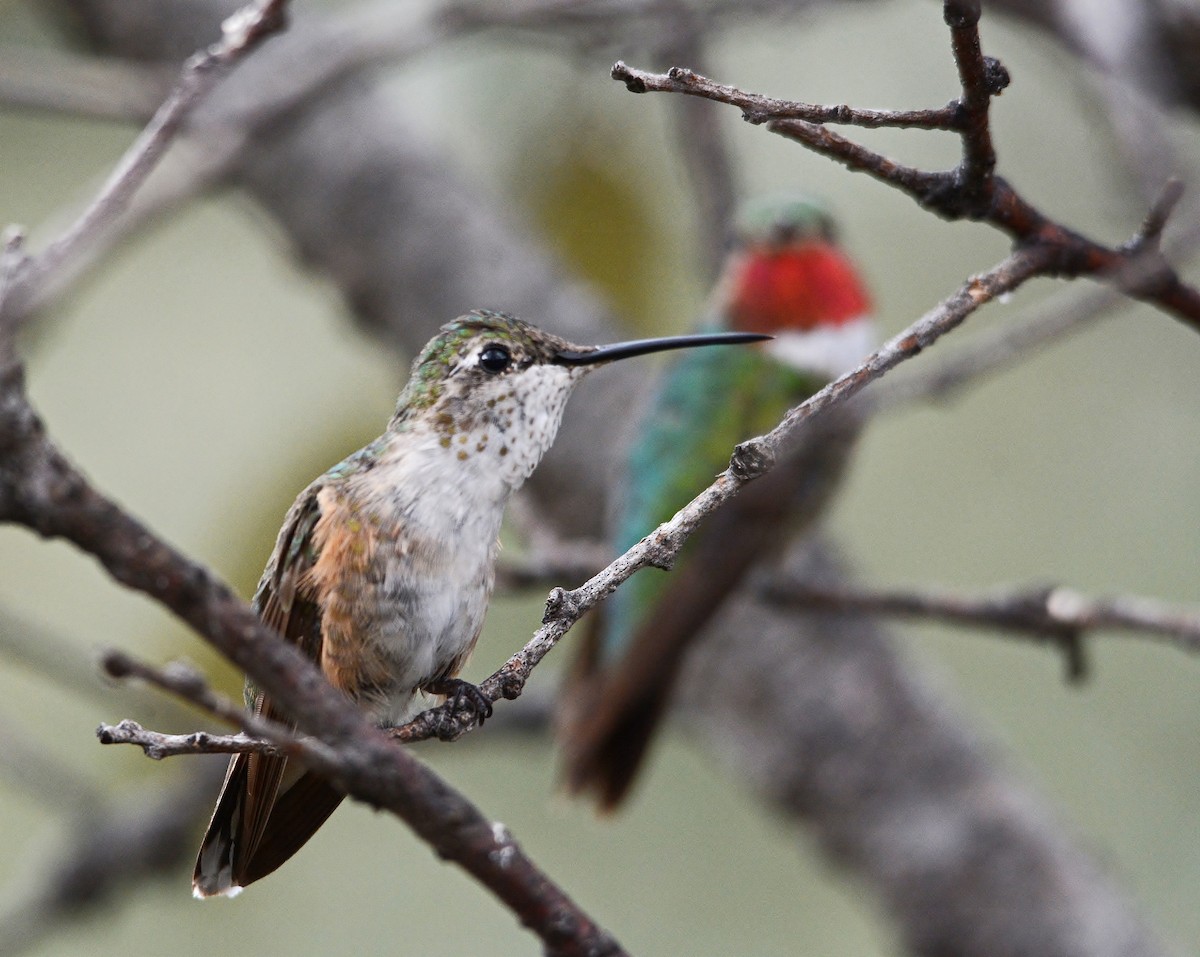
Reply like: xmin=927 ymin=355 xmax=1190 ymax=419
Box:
xmin=0 ymin=375 xmax=619 ymax=953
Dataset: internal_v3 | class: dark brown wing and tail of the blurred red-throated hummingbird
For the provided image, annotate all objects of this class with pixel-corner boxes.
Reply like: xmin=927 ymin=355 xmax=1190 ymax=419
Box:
xmin=562 ymin=419 xmax=858 ymax=811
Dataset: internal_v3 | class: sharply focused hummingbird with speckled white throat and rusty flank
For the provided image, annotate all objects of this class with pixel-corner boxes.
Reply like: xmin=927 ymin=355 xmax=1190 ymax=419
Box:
xmin=192 ymin=311 xmax=764 ymax=897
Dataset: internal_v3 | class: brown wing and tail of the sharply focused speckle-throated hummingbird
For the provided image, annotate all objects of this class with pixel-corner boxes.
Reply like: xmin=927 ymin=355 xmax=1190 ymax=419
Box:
xmin=192 ymin=483 xmax=343 ymax=897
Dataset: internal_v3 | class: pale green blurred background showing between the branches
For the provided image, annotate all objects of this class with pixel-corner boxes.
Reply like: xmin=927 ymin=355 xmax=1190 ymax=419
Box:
xmin=0 ymin=0 xmax=1200 ymax=956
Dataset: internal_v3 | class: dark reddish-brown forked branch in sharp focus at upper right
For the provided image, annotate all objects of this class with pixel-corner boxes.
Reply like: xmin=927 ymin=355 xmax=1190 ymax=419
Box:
xmin=612 ymin=0 xmax=1200 ymax=330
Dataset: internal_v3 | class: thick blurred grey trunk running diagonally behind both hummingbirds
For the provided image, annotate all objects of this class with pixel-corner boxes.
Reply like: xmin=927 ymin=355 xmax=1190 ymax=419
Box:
xmin=18 ymin=0 xmax=1180 ymax=955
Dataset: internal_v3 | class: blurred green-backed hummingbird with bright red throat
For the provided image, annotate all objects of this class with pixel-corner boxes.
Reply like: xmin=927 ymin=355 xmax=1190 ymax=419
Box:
xmin=559 ymin=195 xmax=875 ymax=811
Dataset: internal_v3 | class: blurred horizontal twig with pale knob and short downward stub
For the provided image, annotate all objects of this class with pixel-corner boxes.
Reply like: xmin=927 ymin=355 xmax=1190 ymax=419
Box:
xmin=764 ymin=580 xmax=1200 ymax=680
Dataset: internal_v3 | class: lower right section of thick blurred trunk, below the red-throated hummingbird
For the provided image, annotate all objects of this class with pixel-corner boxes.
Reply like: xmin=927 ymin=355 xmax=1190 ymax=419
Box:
xmin=680 ymin=540 xmax=1170 ymax=957
